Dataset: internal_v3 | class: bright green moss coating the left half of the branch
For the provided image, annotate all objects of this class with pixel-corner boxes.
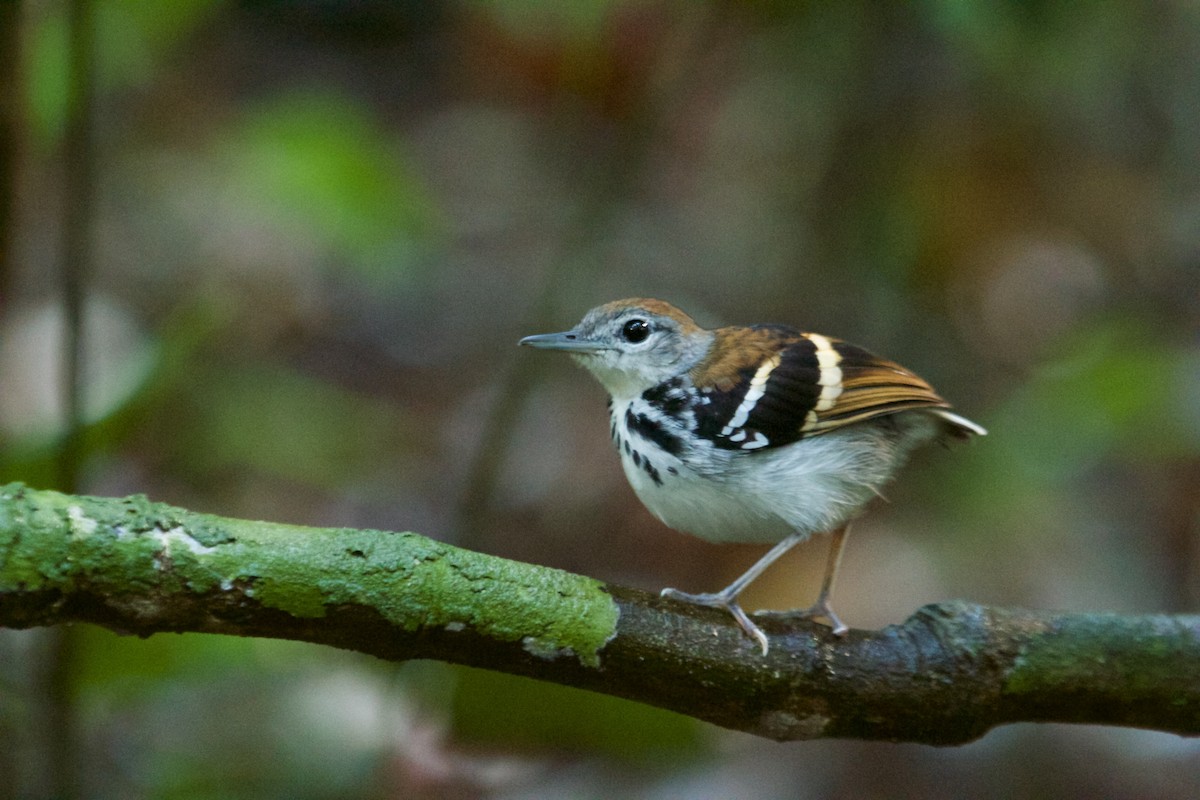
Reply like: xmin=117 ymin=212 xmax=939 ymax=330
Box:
xmin=0 ymin=485 xmax=617 ymax=667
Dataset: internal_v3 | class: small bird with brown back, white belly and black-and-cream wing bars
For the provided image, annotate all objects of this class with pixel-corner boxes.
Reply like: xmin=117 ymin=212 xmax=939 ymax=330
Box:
xmin=518 ymin=297 xmax=988 ymax=656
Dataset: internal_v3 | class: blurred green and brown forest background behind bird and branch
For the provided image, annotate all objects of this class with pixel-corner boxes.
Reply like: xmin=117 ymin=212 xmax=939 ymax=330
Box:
xmin=0 ymin=0 xmax=1200 ymax=799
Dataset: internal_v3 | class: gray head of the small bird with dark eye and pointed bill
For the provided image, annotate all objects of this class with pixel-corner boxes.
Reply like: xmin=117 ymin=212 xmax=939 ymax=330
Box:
xmin=521 ymin=303 xmax=713 ymax=399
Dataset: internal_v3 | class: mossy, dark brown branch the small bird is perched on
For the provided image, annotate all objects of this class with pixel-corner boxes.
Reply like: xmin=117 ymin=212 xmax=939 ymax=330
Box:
xmin=0 ymin=483 xmax=1200 ymax=745
